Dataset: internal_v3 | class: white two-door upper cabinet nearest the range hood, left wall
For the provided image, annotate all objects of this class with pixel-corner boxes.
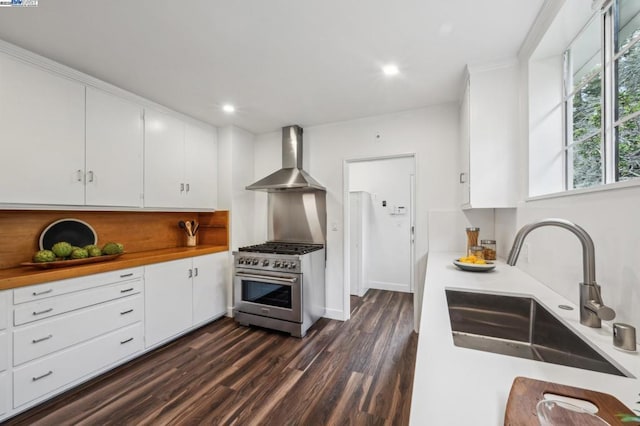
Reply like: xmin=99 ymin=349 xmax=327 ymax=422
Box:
xmin=144 ymin=110 xmax=218 ymax=209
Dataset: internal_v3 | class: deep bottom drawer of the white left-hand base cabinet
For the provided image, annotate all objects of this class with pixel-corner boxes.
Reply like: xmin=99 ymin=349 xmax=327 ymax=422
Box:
xmin=13 ymin=323 xmax=144 ymax=408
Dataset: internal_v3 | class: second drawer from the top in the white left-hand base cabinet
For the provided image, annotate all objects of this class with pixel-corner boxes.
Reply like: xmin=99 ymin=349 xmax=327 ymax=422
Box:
xmin=13 ymin=280 xmax=142 ymax=326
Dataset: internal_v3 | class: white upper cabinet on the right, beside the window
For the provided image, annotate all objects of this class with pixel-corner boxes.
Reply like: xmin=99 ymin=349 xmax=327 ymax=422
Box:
xmin=460 ymin=63 xmax=519 ymax=208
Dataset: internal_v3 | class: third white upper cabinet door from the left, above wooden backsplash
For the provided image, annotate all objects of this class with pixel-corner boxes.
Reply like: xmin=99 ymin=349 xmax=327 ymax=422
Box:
xmin=144 ymin=110 xmax=186 ymax=207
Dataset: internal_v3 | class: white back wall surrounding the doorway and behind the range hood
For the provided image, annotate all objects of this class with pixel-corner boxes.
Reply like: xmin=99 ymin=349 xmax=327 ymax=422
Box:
xmin=255 ymin=104 xmax=459 ymax=319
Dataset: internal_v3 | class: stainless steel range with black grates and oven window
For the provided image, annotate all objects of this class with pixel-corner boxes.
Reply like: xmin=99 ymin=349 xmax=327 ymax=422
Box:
xmin=233 ymin=241 xmax=325 ymax=337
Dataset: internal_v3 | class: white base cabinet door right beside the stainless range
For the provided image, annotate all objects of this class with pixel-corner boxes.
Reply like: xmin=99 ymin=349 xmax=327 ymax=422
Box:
xmin=193 ymin=252 xmax=229 ymax=324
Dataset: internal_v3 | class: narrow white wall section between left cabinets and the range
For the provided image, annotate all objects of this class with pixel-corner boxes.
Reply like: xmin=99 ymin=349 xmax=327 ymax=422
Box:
xmin=218 ymin=126 xmax=256 ymax=315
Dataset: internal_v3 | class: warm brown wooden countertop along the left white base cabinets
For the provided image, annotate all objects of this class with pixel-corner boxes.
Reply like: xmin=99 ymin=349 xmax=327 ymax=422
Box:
xmin=0 ymin=245 xmax=229 ymax=290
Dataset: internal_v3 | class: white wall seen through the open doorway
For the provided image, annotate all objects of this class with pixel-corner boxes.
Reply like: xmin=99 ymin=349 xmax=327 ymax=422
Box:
xmin=348 ymin=157 xmax=415 ymax=292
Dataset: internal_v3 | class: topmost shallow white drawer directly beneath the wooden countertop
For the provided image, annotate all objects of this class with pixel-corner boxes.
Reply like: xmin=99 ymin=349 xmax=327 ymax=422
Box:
xmin=13 ymin=267 xmax=144 ymax=305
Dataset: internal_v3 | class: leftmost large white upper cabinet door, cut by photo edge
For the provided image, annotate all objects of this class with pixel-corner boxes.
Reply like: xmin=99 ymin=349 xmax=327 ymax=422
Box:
xmin=0 ymin=55 xmax=84 ymax=205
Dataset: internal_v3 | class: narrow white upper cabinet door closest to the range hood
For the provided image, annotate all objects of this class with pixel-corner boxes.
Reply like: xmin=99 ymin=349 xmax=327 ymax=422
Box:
xmin=184 ymin=124 xmax=218 ymax=209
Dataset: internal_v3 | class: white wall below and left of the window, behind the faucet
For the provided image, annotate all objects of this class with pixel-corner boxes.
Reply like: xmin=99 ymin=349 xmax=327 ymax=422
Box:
xmin=496 ymin=0 xmax=640 ymax=332
